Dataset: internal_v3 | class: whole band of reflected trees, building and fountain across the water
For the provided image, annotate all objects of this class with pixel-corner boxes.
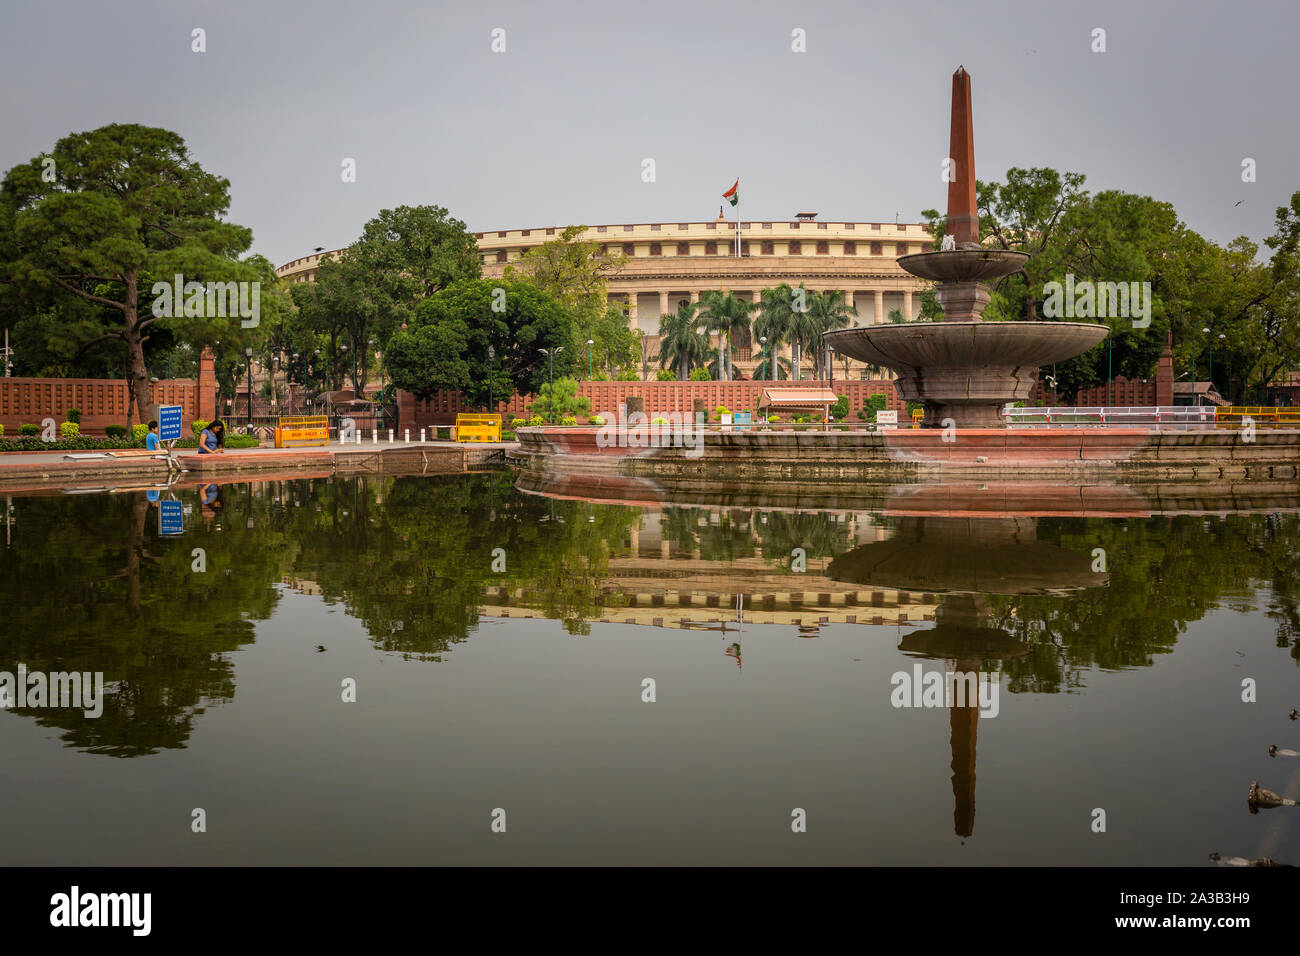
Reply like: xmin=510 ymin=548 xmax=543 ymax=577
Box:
xmin=0 ymin=472 xmax=1300 ymax=780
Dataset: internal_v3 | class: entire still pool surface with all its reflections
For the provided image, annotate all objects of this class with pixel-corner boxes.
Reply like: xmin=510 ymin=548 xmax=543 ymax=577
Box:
xmin=0 ymin=473 xmax=1300 ymax=865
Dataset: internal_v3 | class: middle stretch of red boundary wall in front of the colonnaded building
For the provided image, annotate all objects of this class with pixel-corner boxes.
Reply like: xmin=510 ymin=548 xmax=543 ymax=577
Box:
xmin=398 ymin=378 xmax=907 ymax=428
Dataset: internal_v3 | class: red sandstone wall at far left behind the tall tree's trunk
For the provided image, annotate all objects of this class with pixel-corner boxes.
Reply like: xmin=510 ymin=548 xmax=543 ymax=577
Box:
xmin=0 ymin=378 xmax=199 ymax=438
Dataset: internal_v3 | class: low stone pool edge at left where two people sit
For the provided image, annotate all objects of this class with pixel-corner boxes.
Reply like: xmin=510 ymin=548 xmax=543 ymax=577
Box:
xmin=0 ymin=442 xmax=517 ymax=494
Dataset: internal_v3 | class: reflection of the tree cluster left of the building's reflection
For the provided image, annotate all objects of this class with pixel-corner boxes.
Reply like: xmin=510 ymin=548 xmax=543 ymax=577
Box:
xmin=294 ymin=472 xmax=640 ymax=650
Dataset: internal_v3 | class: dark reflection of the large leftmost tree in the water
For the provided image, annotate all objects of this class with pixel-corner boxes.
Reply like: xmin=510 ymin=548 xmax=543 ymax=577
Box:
xmin=0 ymin=494 xmax=282 ymax=757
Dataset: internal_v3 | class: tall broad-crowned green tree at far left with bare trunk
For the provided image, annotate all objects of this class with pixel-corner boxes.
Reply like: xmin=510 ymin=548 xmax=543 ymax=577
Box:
xmin=0 ymin=124 xmax=261 ymax=421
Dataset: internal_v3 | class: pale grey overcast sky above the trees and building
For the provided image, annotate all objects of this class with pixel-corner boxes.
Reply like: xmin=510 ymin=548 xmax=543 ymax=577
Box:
xmin=0 ymin=0 xmax=1300 ymax=264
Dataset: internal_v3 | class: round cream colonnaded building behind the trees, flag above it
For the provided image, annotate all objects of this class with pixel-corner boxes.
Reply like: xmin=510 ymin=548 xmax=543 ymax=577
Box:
xmin=276 ymin=213 xmax=931 ymax=377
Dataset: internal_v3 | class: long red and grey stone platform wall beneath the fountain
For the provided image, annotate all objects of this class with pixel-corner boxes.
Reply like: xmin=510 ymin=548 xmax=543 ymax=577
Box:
xmin=510 ymin=428 xmax=1300 ymax=493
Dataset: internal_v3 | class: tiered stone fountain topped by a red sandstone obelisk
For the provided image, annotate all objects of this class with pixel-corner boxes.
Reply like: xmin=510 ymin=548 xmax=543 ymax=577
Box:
xmin=826 ymin=68 xmax=1106 ymax=428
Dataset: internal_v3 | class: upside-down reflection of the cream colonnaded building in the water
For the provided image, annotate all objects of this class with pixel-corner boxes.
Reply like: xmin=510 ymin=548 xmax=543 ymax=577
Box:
xmin=478 ymin=510 xmax=936 ymax=631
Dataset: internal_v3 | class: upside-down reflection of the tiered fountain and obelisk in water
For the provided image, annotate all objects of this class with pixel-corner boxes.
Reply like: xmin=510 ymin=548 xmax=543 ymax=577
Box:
xmin=827 ymin=518 xmax=1108 ymax=839
